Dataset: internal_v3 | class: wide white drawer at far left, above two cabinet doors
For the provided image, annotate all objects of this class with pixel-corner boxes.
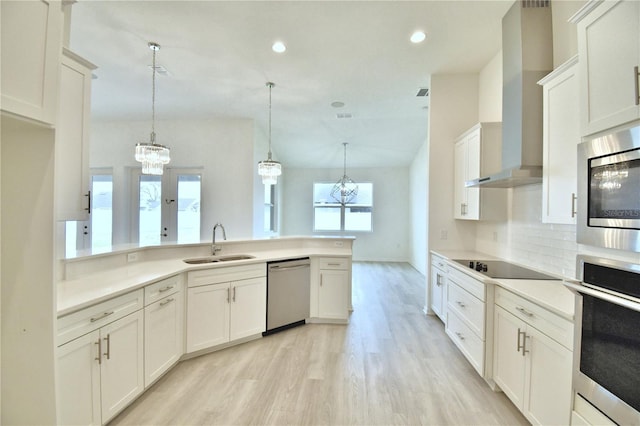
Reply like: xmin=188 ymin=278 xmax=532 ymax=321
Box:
xmin=57 ymin=289 xmax=143 ymax=346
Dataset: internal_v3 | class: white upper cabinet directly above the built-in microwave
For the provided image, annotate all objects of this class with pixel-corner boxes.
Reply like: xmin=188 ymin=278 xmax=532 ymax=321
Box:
xmin=572 ymin=0 xmax=640 ymax=136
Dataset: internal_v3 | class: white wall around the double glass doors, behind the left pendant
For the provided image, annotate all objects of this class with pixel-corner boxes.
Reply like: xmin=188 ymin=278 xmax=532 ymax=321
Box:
xmin=90 ymin=118 xmax=261 ymax=244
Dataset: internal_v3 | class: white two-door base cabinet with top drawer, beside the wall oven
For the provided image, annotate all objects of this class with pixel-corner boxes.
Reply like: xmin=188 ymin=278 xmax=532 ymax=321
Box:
xmin=493 ymin=288 xmax=573 ymax=425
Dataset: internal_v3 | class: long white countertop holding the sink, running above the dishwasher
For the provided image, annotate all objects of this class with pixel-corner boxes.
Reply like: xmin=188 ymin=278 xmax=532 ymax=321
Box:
xmin=57 ymin=247 xmax=351 ymax=317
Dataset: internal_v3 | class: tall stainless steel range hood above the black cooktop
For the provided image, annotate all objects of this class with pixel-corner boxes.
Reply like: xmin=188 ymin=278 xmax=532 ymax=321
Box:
xmin=465 ymin=0 xmax=553 ymax=188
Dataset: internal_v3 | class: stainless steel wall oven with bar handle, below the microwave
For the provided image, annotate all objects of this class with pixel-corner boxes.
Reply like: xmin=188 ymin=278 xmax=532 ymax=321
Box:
xmin=565 ymin=256 xmax=640 ymax=424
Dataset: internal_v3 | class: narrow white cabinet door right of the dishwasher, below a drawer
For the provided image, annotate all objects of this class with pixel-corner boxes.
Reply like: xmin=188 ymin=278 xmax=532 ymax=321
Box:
xmin=318 ymin=270 xmax=349 ymax=320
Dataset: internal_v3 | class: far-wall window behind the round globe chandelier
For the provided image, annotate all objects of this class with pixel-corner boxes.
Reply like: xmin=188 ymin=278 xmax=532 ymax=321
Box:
xmin=313 ymin=183 xmax=373 ymax=232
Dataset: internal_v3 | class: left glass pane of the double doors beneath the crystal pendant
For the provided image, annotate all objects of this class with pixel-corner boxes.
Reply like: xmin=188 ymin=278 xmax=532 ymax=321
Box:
xmin=138 ymin=175 xmax=162 ymax=246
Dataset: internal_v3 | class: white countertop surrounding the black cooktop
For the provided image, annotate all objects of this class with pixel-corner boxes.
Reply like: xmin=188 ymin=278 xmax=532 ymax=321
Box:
xmin=431 ymin=250 xmax=575 ymax=321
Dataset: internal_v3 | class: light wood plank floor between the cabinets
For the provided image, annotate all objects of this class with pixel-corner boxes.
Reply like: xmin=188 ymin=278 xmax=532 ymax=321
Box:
xmin=112 ymin=262 xmax=528 ymax=425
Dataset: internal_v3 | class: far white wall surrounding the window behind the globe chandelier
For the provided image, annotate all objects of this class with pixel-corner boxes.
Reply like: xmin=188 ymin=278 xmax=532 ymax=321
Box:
xmin=280 ymin=168 xmax=410 ymax=262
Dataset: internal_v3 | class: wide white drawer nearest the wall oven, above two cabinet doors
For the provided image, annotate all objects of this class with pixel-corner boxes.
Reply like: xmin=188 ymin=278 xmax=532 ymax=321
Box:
xmin=496 ymin=287 xmax=573 ymax=351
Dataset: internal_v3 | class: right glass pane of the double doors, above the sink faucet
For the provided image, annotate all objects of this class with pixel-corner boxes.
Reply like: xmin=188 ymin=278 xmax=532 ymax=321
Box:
xmin=178 ymin=175 xmax=201 ymax=243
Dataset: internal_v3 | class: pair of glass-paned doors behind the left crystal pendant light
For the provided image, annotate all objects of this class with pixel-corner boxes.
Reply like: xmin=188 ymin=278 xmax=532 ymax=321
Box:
xmin=132 ymin=168 xmax=202 ymax=246
